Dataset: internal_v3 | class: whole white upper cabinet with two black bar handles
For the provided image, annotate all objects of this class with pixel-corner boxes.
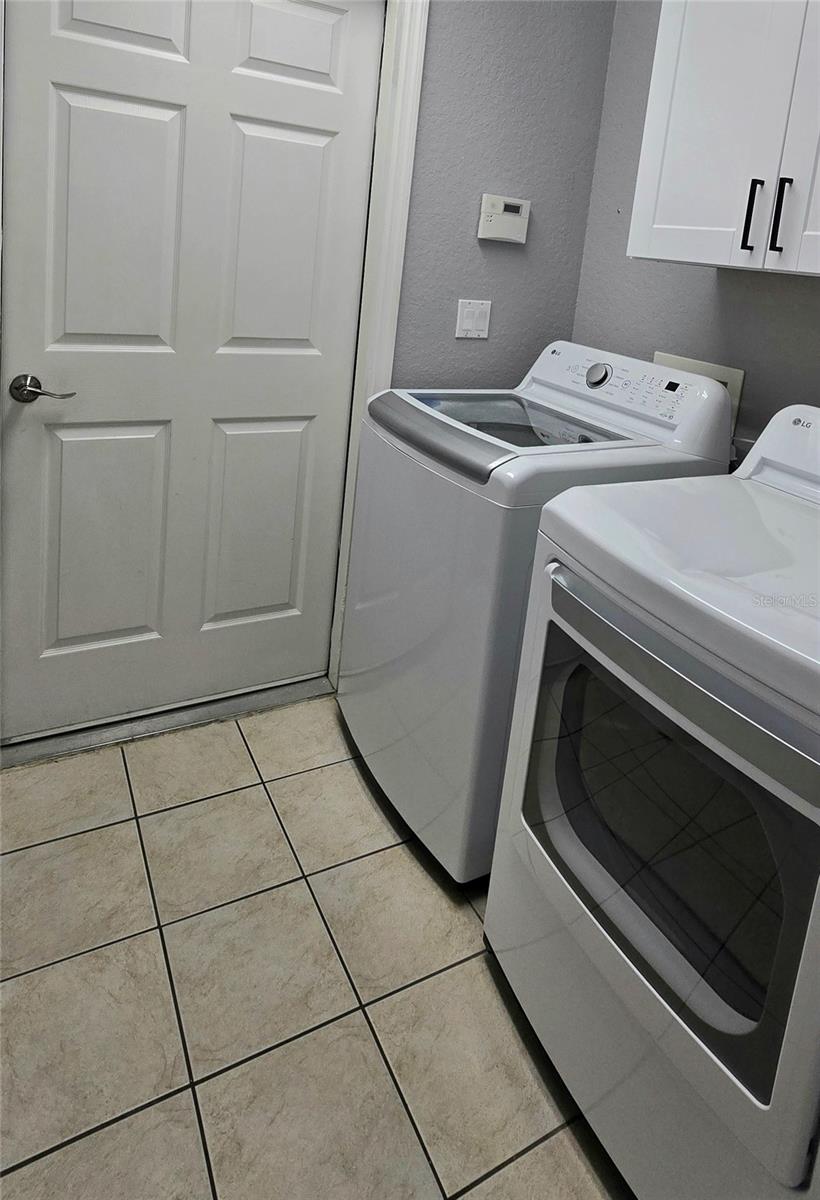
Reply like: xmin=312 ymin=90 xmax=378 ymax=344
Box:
xmin=627 ymin=0 xmax=820 ymax=274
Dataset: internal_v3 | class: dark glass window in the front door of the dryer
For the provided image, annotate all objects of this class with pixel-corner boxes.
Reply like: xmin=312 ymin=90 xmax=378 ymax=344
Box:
xmin=523 ymin=624 xmax=820 ymax=1102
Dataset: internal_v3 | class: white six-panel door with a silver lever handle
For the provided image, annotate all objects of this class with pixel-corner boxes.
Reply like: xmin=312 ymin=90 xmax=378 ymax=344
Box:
xmin=2 ymin=0 xmax=384 ymax=738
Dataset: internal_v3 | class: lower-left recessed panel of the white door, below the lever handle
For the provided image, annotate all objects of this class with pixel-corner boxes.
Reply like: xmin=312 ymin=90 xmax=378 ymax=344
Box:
xmin=44 ymin=424 xmax=168 ymax=653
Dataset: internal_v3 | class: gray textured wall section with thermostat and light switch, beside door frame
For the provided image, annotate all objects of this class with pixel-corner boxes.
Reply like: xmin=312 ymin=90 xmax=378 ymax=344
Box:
xmin=394 ymin=0 xmax=613 ymax=386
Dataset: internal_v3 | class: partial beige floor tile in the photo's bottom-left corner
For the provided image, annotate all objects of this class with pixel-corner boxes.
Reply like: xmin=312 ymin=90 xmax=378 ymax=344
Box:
xmin=2 ymin=1092 xmax=211 ymax=1200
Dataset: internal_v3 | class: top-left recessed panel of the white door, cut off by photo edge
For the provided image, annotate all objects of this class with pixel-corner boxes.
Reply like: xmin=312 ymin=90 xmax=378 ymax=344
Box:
xmin=55 ymin=0 xmax=191 ymax=58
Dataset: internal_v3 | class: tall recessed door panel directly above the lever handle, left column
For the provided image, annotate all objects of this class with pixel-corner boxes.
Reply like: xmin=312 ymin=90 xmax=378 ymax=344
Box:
xmin=50 ymin=89 xmax=184 ymax=350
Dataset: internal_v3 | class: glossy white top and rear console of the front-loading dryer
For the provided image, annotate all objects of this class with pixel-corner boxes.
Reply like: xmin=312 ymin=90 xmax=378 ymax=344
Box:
xmin=541 ymin=406 xmax=820 ymax=714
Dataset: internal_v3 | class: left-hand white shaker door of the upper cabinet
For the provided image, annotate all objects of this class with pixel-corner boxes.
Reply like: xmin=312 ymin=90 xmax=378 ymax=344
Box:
xmin=628 ymin=0 xmax=807 ymax=268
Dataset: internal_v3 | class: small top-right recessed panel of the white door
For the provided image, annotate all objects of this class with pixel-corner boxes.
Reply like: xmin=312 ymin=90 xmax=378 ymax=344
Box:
xmin=239 ymin=0 xmax=345 ymax=86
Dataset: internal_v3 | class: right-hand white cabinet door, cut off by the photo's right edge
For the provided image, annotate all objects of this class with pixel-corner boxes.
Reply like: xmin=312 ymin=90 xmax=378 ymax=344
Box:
xmin=766 ymin=0 xmax=820 ymax=275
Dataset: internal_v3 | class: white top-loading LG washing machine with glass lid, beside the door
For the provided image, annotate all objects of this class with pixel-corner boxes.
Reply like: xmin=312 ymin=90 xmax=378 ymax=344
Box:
xmin=339 ymin=342 xmax=730 ymax=882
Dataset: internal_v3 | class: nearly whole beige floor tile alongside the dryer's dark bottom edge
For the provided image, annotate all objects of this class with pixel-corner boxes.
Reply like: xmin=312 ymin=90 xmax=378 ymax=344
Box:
xmin=369 ymin=958 xmax=564 ymax=1193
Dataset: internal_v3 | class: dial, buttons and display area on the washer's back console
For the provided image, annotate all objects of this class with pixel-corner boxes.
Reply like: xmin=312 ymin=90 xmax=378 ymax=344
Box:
xmin=563 ymin=356 xmax=698 ymax=425
